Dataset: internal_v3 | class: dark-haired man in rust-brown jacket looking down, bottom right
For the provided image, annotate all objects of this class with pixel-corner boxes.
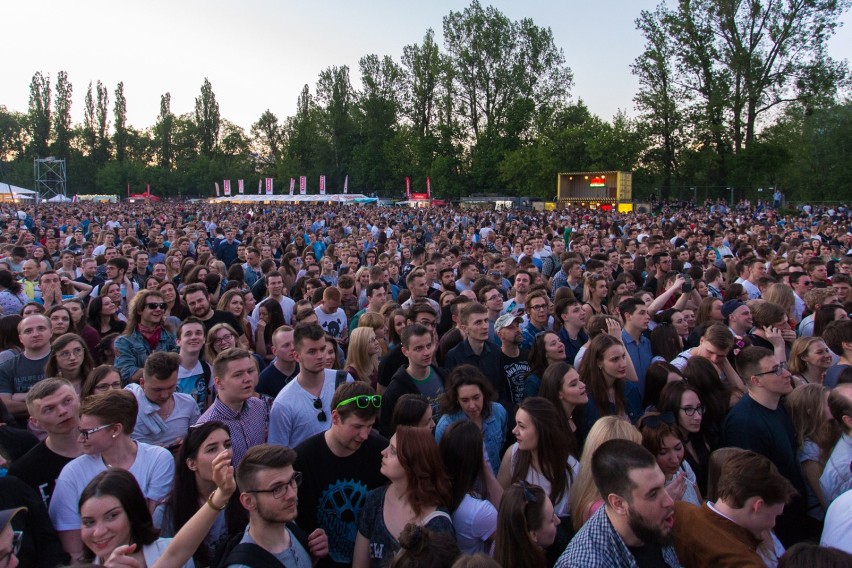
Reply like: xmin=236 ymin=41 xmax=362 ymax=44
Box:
xmin=673 ymin=450 xmax=796 ymax=568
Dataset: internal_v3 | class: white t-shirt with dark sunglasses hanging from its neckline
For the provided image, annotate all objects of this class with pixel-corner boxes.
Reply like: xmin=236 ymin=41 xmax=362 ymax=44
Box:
xmin=267 ymin=369 xmax=354 ymax=448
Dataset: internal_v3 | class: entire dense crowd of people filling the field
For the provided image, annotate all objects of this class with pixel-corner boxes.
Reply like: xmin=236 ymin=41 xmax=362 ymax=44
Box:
xmin=0 ymin=196 xmax=852 ymax=568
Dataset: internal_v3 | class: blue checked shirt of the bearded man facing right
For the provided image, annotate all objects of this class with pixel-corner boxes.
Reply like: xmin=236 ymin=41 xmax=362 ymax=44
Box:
xmin=555 ymin=506 xmax=681 ymax=568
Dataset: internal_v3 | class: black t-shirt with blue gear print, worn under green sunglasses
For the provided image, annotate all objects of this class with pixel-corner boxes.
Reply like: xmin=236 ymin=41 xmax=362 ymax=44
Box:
xmin=293 ymin=431 xmax=388 ymax=567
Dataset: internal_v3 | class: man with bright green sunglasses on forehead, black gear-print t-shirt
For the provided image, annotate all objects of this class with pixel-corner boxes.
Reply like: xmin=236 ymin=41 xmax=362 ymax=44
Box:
xmin=293 ymin=381 xmax=388 ymax=568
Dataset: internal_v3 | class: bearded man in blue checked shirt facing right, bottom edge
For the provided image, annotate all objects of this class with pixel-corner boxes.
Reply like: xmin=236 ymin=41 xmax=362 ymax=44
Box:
xmin=556 ymin=440 xmax=684 ymax=568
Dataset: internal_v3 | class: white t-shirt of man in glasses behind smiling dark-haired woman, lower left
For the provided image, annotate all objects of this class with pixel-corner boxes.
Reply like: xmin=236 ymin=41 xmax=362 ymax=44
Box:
xmin=48 ymin=442 xmax=175 ymax=531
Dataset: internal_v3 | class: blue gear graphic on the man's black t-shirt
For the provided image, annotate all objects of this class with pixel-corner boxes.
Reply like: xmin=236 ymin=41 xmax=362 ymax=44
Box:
xmin=317 ymin=479 xmax=369 ymax=563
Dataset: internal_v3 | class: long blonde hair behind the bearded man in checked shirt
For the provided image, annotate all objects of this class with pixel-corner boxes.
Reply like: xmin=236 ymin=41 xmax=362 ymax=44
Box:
xmin=571 ymin=416 xmax=642 ymax=531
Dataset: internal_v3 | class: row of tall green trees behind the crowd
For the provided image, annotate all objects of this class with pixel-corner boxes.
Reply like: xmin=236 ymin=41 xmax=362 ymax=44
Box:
xmin=0 ymin=0 xmax=852 ymax=199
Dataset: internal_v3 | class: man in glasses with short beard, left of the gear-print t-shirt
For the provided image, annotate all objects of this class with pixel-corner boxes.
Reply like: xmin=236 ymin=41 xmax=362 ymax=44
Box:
xmin=219 ymin=444 xmax=328 ymax=568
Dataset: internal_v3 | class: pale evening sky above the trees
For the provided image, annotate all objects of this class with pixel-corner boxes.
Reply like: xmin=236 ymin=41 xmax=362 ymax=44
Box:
xmin=0 ymin=0 xmax=852 ymax=130
